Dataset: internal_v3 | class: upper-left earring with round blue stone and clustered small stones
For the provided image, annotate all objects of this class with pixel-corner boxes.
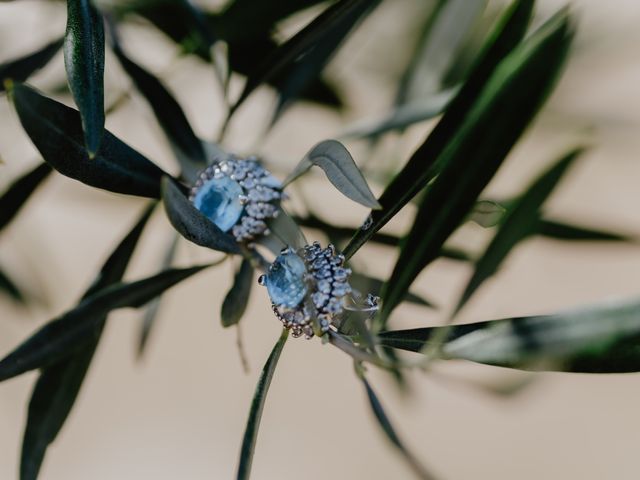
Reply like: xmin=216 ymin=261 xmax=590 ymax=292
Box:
xmin=189 ymin=155 xmax=284 ymax=243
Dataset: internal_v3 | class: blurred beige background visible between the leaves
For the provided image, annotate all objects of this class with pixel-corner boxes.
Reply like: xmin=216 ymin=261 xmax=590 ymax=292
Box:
xmin=0 ymin=0 xmax=640 ymax=480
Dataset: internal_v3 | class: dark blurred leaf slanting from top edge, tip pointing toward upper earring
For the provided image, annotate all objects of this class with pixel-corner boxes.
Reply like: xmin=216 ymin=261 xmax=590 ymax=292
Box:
xmin=229 ymin=0 xmax=378 ymax=116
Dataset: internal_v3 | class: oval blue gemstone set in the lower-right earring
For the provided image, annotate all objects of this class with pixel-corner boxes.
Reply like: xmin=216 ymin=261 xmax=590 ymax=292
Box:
xmin=266 ymin=252 xmax=307 ymax=308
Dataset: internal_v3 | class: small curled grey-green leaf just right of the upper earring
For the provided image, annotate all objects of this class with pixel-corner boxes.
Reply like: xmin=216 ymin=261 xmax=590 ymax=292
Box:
xmin=284 ymin=140 xmax=380 ymax=208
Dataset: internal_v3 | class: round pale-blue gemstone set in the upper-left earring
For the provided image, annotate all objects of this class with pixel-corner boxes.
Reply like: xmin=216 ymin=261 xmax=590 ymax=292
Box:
xmin=193 ymin=177 xmax=244 ymax=232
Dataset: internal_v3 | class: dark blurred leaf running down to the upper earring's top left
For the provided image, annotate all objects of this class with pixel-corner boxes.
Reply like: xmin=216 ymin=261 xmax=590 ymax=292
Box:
xmin=112 ymin=31 xmax=207 ymax=181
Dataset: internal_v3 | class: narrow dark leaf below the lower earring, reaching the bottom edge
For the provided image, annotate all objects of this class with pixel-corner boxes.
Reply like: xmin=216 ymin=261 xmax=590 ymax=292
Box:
xmin=236 ymin=329 xmax=289 ymax=480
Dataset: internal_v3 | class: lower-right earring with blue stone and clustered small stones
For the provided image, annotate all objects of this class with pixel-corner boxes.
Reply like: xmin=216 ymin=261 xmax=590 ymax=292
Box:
xmin=259 ymin=242 xmax=351 ymax=338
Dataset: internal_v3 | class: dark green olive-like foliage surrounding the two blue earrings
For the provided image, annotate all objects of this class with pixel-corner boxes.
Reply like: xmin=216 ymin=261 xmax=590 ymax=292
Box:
xmin=0 ymin=0 xmax=640 ymax=480
